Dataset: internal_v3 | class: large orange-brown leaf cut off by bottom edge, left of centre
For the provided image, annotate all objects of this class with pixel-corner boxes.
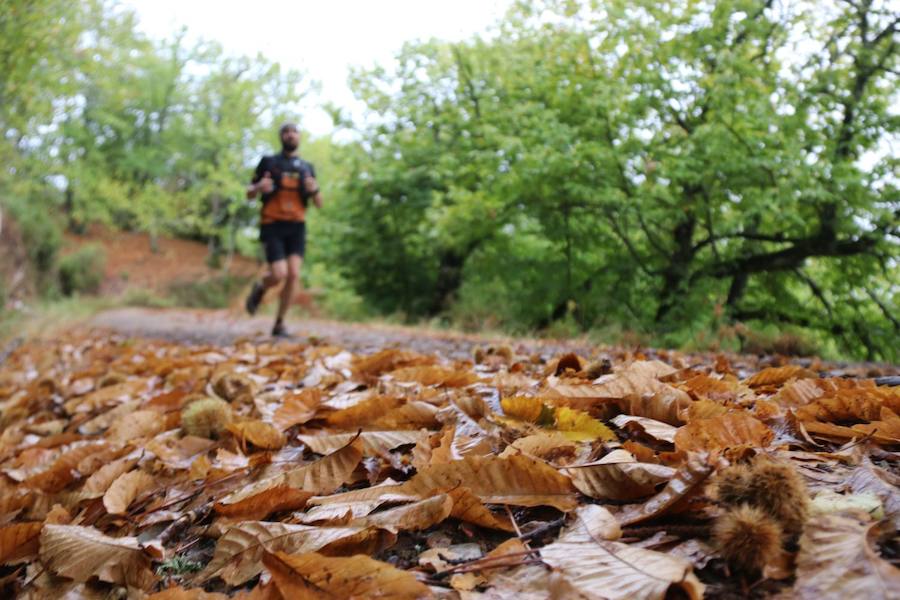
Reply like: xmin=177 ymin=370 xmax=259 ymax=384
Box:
xmin=263 ymin=552 xmax=433 ymax=600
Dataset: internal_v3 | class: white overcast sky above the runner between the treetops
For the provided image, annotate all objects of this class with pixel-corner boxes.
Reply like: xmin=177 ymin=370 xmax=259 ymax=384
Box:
xmin=120 ymin=0 xmax=512 ymax=135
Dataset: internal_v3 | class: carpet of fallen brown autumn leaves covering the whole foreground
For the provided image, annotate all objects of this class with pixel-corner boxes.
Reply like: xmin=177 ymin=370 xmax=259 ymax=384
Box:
xmin=0 ymin=330 xmax=900 ymax=600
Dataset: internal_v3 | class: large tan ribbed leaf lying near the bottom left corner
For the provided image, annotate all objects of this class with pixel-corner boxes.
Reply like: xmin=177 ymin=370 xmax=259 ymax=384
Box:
xmin=40 ymin=525 xmax=156 ymax=589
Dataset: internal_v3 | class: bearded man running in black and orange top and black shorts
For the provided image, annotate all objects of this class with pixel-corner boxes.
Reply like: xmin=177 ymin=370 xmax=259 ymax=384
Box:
xmin=245 ymin=123 xmax=322 ymax=337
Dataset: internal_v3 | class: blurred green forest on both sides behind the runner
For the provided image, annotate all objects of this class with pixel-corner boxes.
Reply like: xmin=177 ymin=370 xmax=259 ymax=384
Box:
xmin=0 ymin=0 xmax=900 ymax=362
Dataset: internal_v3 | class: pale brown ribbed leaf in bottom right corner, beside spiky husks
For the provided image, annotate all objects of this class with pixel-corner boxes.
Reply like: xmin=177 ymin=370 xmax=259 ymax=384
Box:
xmin=793 ymin=515 xmax=900 ymax=600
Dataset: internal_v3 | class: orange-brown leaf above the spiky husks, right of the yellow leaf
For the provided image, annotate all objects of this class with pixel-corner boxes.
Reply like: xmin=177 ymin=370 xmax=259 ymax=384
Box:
xmin=675 ymin=412 xmax=775 ymax=452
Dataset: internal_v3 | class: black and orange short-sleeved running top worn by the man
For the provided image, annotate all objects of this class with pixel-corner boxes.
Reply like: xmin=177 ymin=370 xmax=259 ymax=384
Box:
xmin=252 ymin=153 xmax=316 ymax=223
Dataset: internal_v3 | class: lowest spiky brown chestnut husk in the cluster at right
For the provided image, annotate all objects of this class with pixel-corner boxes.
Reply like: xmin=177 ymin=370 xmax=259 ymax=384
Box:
xmin=713 ymin=504 xmax=784 ymax=575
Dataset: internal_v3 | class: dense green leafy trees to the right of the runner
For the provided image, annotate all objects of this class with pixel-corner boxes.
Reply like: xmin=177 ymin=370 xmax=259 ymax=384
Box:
xmin=321 ymin=0 xmax=900 ymax=360
